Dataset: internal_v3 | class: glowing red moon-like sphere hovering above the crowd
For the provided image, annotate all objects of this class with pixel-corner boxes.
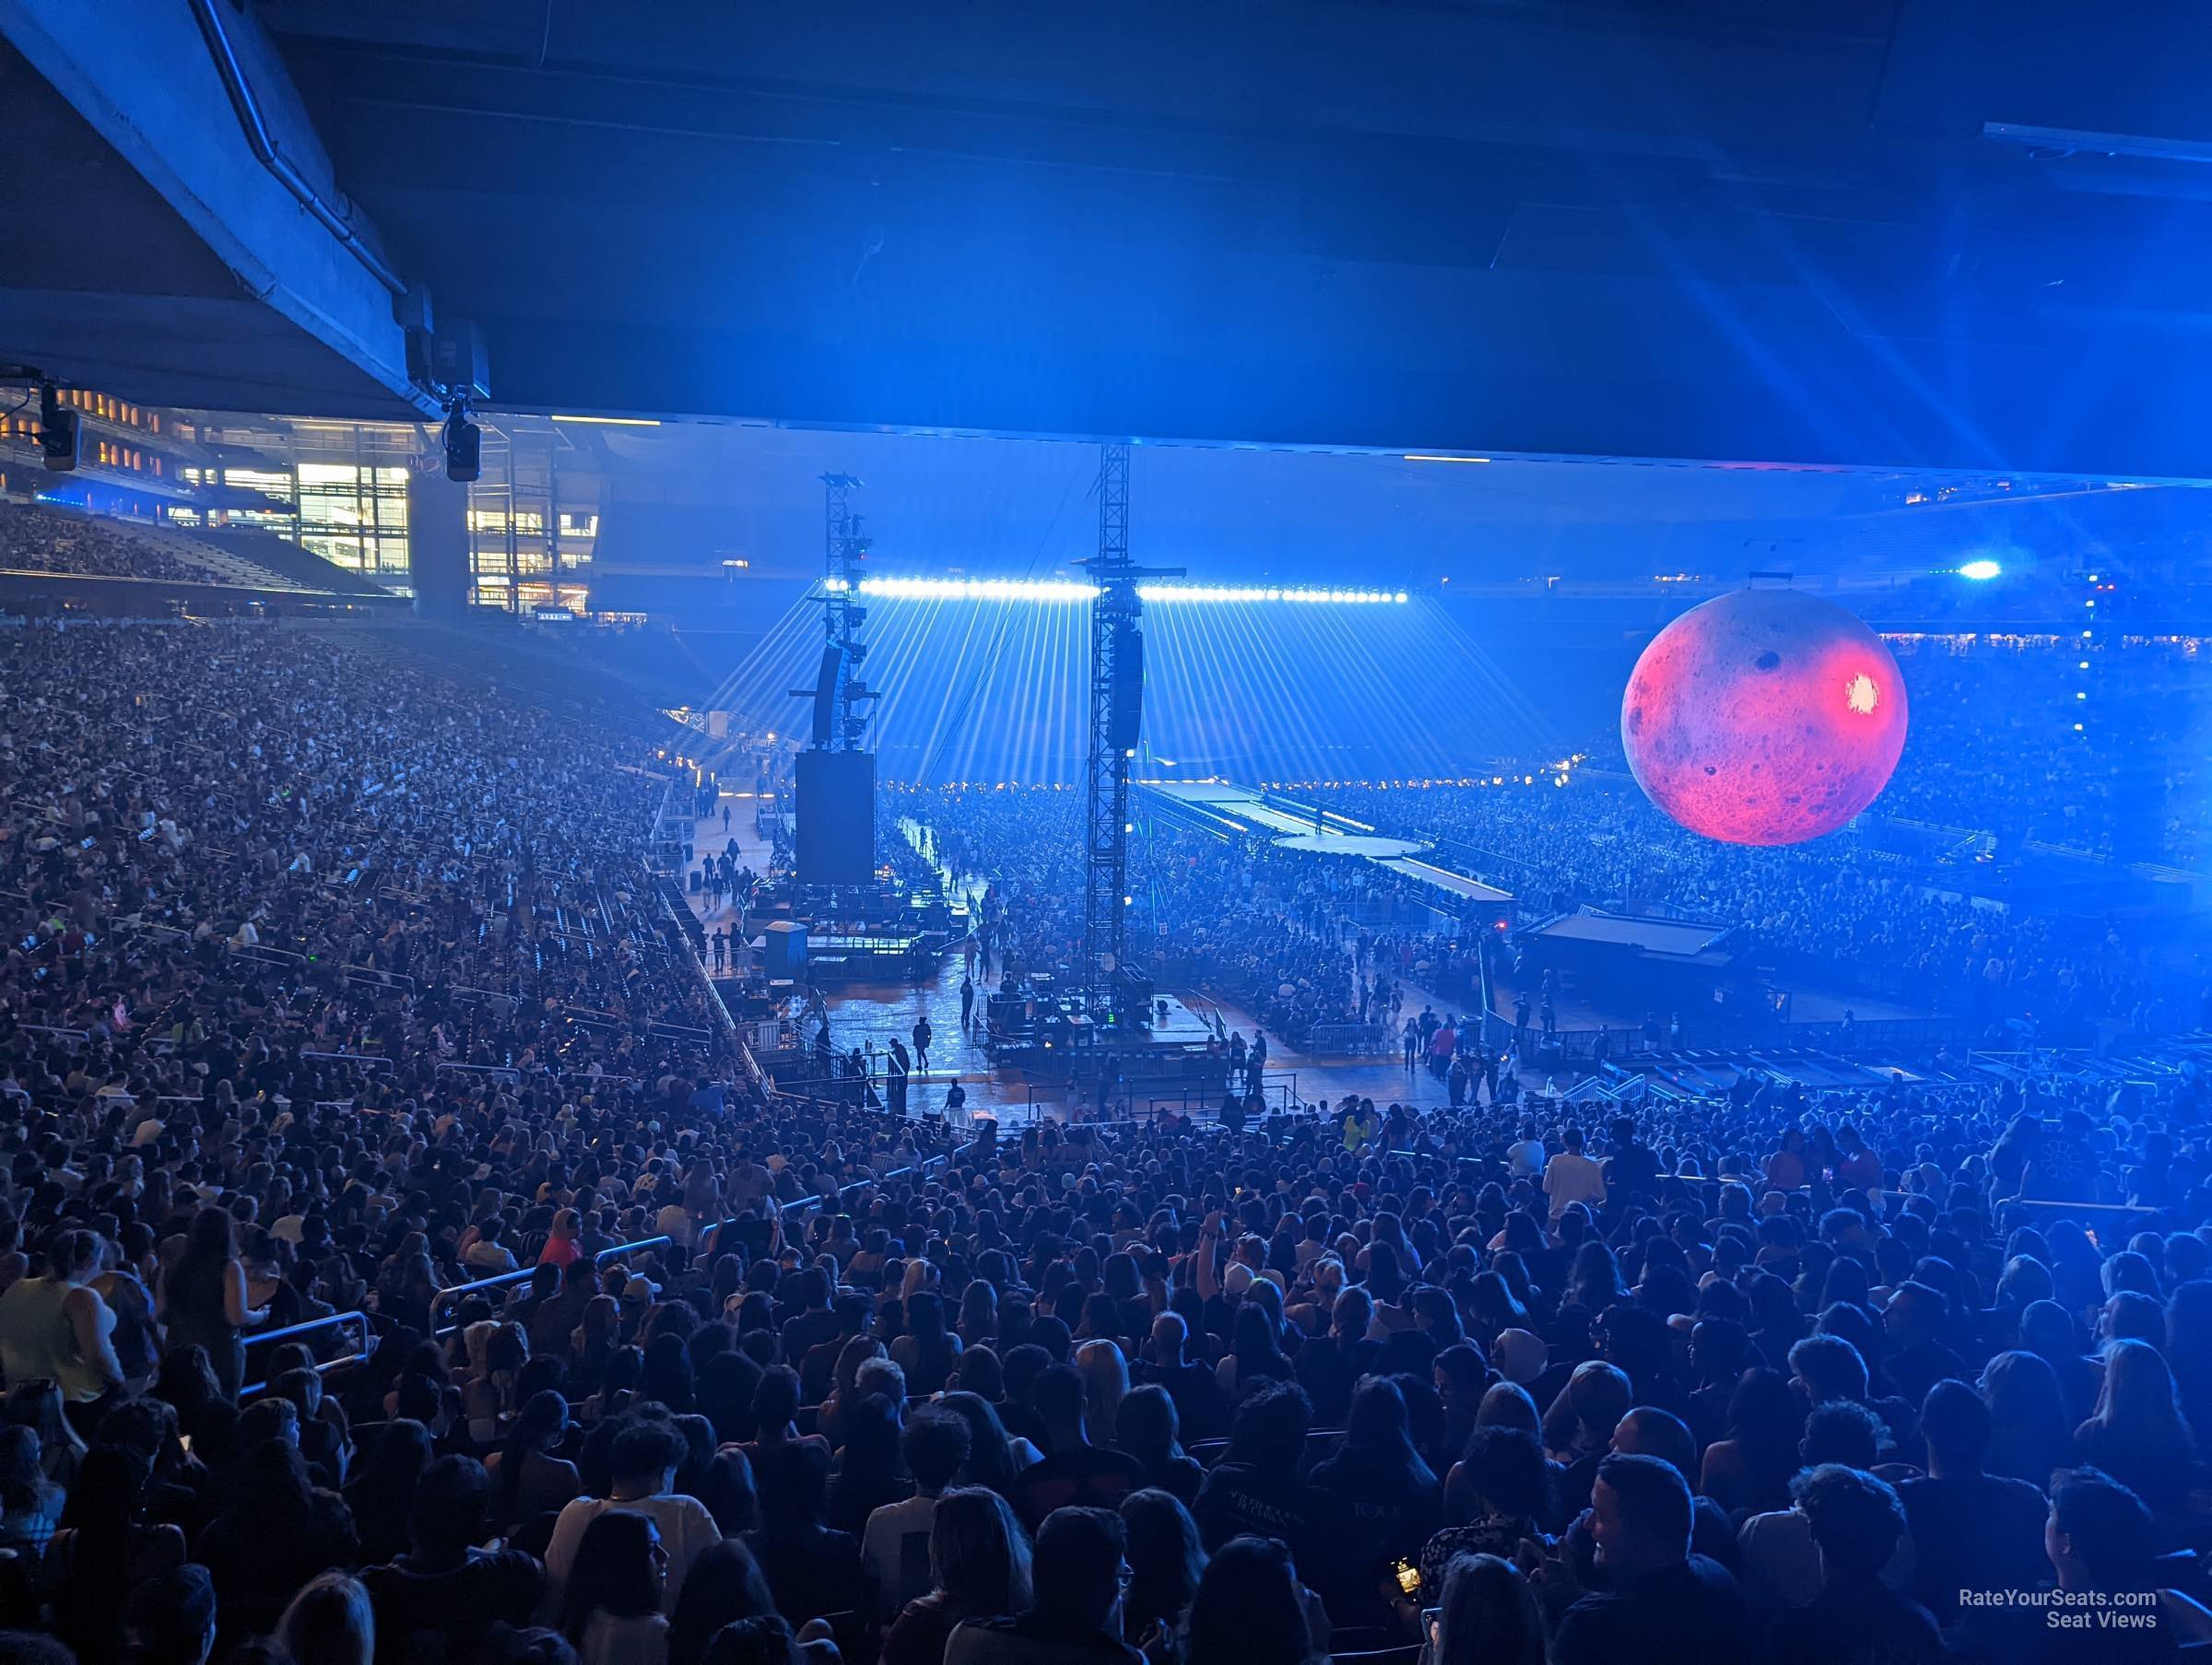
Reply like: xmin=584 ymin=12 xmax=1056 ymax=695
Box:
xmin=1621 ymin=591 xmax=1904 ymax=845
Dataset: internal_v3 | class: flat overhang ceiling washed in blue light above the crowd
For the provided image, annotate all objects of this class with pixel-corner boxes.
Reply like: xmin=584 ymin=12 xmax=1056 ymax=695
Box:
xmin=13 ymin=0 xmax=2212 ymax=477
